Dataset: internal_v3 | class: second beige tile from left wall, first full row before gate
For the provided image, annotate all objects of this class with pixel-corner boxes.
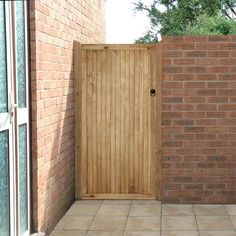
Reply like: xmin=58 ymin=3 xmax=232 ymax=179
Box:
xmin=97 ymin=205 xmax=130 ymax=216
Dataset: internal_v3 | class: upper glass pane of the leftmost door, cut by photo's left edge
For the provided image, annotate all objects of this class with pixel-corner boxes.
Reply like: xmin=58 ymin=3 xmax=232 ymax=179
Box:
xmin=0 ymin=1 xmax=7 ymax=113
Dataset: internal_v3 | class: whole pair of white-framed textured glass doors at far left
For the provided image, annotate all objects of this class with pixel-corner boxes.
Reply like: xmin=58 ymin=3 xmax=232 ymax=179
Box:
xmin=0 ymin=0 xmax=30 ymax=236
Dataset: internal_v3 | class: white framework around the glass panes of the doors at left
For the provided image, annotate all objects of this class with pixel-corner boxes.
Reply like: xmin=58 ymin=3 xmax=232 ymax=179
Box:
xmin=0 ymin=1 xmax=31 ymax=236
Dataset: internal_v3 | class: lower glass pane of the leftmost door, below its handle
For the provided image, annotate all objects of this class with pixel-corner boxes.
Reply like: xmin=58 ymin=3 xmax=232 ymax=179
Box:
xmin=0 ymin=131 xmax=10 ymax=236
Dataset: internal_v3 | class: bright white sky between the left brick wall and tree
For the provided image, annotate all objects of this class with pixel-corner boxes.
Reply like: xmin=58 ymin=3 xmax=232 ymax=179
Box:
xmin=106 ymin=0 xmax=152 ymax=44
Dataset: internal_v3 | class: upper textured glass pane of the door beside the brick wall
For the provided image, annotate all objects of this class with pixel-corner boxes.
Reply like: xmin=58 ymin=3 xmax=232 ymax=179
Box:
xmin=15 ymin=1 xmax=26 ymax=108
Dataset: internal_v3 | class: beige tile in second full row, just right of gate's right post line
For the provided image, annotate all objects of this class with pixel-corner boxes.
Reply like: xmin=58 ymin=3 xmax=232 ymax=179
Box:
xmin=162 ymin=216 xmax=197 ymax=231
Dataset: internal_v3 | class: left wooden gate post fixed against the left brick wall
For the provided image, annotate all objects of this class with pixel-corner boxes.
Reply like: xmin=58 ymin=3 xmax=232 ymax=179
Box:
xmin=74 ymin=42 xmax=83 ymax=199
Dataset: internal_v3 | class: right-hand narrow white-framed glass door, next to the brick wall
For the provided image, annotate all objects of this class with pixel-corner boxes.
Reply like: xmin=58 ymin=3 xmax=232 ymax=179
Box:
xmin=14 ymin=1 xmax=29 ymax=236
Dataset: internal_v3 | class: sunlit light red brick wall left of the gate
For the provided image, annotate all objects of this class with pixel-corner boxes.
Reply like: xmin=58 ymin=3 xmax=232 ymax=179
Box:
xmin=29 ymin=0 xmax=105 ymax=231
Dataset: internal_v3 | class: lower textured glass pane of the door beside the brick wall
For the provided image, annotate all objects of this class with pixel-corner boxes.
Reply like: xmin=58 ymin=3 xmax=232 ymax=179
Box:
xmin=19 ymin=124 xmax=28 ymax=235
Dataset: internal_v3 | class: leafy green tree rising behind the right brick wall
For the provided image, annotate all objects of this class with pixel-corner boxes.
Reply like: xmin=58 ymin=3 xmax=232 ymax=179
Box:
xmin=134 ymin=0 xmax=236 ymax=43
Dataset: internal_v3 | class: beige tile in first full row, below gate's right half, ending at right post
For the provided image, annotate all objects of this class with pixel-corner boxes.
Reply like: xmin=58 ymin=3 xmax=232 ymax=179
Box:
xmin=129 ymin=204 xmax=161 ymax=216
